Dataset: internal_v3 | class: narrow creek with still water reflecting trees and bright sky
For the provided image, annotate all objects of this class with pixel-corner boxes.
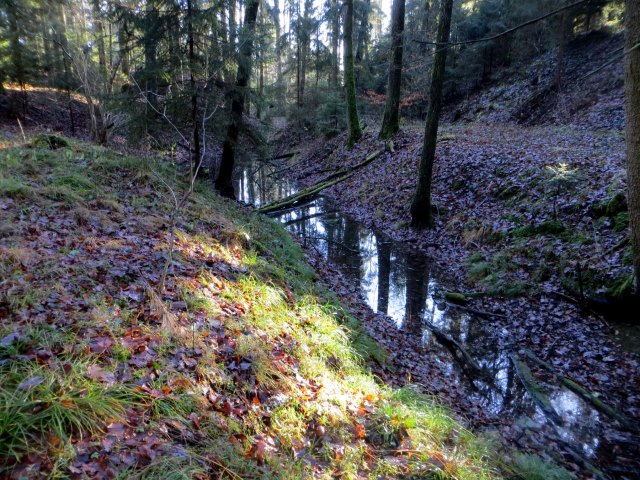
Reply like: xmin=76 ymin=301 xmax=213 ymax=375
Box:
xmin=235 ymin=155 xmax=628 ymax=476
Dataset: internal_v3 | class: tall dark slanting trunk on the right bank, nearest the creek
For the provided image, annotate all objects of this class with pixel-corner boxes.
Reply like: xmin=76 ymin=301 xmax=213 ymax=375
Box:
xmin=411 ymin=0 xmax=453 ymax=228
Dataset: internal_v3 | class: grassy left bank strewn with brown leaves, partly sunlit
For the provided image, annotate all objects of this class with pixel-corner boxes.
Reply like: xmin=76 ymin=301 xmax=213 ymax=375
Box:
xmin=0 ymin=135 xmax=568 ymax=479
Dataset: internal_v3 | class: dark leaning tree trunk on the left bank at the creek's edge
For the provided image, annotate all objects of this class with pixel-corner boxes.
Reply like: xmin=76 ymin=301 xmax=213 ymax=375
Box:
xmin=215 ymin=0 xmax=260 ymax=198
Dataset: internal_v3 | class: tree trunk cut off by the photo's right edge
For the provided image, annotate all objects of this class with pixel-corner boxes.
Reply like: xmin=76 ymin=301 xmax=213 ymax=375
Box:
xmin=625 ymin=0 xmax=640 ymax=299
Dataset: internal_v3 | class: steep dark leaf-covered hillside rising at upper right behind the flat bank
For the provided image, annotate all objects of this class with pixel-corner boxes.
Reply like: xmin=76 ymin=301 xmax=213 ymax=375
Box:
xmin=444 ymin=31 xmax=624 ymax=131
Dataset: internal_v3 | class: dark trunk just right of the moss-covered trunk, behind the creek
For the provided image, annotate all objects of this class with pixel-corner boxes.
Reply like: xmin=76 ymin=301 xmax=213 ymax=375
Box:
xmin=379 ymin=0 xmax=405 ymax=140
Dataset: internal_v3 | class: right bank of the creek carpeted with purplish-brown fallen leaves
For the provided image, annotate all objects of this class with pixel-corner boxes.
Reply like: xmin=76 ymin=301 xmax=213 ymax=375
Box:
xmin=274 ymin=118 xmax=640 ymax=478
